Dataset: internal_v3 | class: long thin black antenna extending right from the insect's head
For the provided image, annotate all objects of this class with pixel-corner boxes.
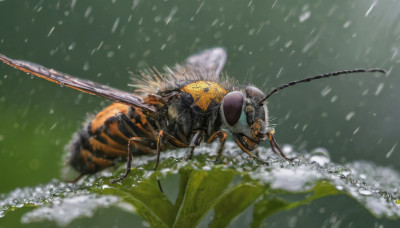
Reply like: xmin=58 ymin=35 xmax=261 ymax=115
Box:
xmin=260 ymin=68 xmax=387 ymax=104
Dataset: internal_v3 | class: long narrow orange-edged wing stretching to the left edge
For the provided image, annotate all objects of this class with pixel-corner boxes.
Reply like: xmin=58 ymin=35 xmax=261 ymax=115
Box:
xmin=0 ymin=54 xmax=156 ymax=112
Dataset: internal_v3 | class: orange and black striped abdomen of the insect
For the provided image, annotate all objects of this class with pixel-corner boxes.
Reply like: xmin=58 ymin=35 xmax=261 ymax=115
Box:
xmin=68 ymin=103 xmax=156 ymax=174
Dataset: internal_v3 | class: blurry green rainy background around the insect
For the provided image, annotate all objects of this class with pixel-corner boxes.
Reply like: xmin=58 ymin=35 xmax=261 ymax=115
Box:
xmin=0 ymin=0 xmax=400 ymax=226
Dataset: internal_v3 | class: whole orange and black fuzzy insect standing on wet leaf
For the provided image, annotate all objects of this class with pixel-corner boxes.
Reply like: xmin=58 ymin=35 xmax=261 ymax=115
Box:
xmin=0 ymin=47 xmax=386 ymax=189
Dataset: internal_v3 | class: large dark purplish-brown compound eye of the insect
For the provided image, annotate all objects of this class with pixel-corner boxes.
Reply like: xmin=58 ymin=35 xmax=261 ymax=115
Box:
xmin=222 ymin=92 xmax=244 ymax=126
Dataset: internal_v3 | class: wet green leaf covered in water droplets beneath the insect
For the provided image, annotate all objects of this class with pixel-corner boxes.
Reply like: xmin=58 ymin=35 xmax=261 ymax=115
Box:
xmin=0 ymin=147 xmax=400 ymax=227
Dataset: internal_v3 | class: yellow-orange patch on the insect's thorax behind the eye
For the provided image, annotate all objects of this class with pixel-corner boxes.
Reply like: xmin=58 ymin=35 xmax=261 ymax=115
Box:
xmin=181 ymin=81 xmax=227 ymax=111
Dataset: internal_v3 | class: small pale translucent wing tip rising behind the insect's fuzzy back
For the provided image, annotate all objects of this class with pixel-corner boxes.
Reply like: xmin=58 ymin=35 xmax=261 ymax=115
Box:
xmin=186 ymin=47 xmax=227 ymax=77
